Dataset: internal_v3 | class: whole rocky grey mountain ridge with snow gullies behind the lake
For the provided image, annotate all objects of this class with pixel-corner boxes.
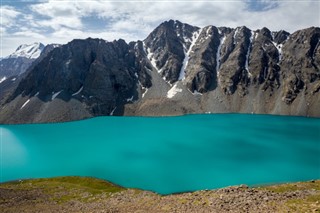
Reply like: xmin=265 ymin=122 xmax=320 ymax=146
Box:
xmin=0 ymin=20 xmax=320 ymax=123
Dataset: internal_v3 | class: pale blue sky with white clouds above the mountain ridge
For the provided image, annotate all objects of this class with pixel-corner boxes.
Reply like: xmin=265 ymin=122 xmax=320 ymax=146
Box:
xmin=0 ymin=0 xmax=320 ymax=57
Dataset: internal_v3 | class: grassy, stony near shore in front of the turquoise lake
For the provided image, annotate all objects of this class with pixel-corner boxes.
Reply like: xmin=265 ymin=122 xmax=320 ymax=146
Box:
xmin=0 ymin=177 xmax=320 ymax=212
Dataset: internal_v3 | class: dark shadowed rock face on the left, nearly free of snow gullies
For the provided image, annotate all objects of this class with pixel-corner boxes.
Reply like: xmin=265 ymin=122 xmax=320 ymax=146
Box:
xmin=7 ymin=39 xmax=136 ymax=115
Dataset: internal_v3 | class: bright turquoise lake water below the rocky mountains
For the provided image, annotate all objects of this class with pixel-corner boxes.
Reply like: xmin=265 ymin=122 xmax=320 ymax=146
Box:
xmin=0 ymin=114 xmax=320 ymax=194
